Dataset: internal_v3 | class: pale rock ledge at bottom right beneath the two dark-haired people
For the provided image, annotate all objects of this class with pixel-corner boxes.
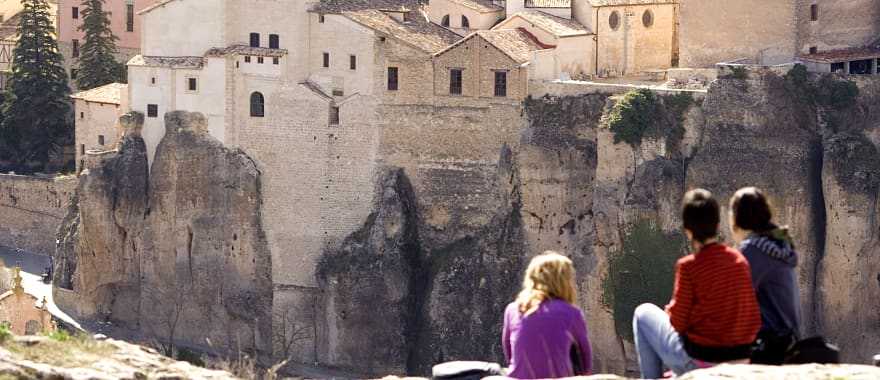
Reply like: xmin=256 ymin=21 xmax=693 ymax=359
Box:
xmin=383 ymin=364 xmax=880 ymax=380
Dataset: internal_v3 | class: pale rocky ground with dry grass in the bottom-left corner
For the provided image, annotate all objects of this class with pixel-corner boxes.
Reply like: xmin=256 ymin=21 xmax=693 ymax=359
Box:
xmin=0 ymin=337 xmax=236 ymax=380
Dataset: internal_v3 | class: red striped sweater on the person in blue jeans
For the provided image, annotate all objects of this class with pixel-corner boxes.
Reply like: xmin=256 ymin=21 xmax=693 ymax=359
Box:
xmin=666 ymin=244 xmax=761 ymax=347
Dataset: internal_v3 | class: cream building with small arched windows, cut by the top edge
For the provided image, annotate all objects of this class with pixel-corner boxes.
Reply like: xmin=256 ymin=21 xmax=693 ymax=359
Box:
xmin=427 ymin=0 xmax=504 ymax=36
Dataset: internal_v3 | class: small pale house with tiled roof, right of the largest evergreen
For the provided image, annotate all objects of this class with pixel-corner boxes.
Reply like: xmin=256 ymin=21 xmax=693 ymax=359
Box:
xmin=70 ymin=83 xmax=128 ymax=172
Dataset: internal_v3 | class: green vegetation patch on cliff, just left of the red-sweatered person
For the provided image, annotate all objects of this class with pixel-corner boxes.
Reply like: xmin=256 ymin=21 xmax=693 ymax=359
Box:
xmin=602 ymin=220 xmax=685 ymax=341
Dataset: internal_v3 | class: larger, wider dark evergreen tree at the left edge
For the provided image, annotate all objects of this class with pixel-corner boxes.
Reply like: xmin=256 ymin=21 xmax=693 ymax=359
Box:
xmin=0 ymin=0 xmax=73 ymax=170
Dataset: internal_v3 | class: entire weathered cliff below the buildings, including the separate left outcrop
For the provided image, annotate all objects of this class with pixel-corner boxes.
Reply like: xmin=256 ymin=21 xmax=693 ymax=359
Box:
xmin=56 ymin=68 xmax=880 ymax=375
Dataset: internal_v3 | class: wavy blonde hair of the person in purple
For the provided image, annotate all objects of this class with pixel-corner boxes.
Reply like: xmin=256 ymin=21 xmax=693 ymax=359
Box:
xmin=516 ymin=251 xmax=577 ymax=315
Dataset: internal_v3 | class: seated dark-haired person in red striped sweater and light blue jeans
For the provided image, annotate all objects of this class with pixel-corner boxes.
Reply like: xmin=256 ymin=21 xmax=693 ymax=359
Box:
xmin=633 ymin=189 xmax=761 ymax=379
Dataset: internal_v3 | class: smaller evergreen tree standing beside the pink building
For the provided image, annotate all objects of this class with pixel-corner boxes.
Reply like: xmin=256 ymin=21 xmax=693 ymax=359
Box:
xmin=76 ymin=0 xmax=125 ymax=90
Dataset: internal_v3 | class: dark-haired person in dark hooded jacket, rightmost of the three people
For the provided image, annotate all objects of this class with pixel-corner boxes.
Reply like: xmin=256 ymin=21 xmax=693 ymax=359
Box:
xmin=730 ymin=187 xmax=800 ymax=364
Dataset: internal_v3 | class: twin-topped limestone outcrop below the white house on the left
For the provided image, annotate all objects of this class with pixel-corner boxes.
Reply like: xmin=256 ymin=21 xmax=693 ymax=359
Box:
xmin=56 ymin=112 xmax=272 ymax=352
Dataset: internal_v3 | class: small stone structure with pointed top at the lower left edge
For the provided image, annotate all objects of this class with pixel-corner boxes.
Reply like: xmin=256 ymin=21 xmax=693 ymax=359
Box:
xmin=0 ymin=265 xmax=54 ymax=335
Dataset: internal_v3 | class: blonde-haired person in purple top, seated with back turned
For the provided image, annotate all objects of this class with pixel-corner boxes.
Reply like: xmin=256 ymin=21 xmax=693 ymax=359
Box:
xmin=502 ymin=251 xmax=592 ymax=379
